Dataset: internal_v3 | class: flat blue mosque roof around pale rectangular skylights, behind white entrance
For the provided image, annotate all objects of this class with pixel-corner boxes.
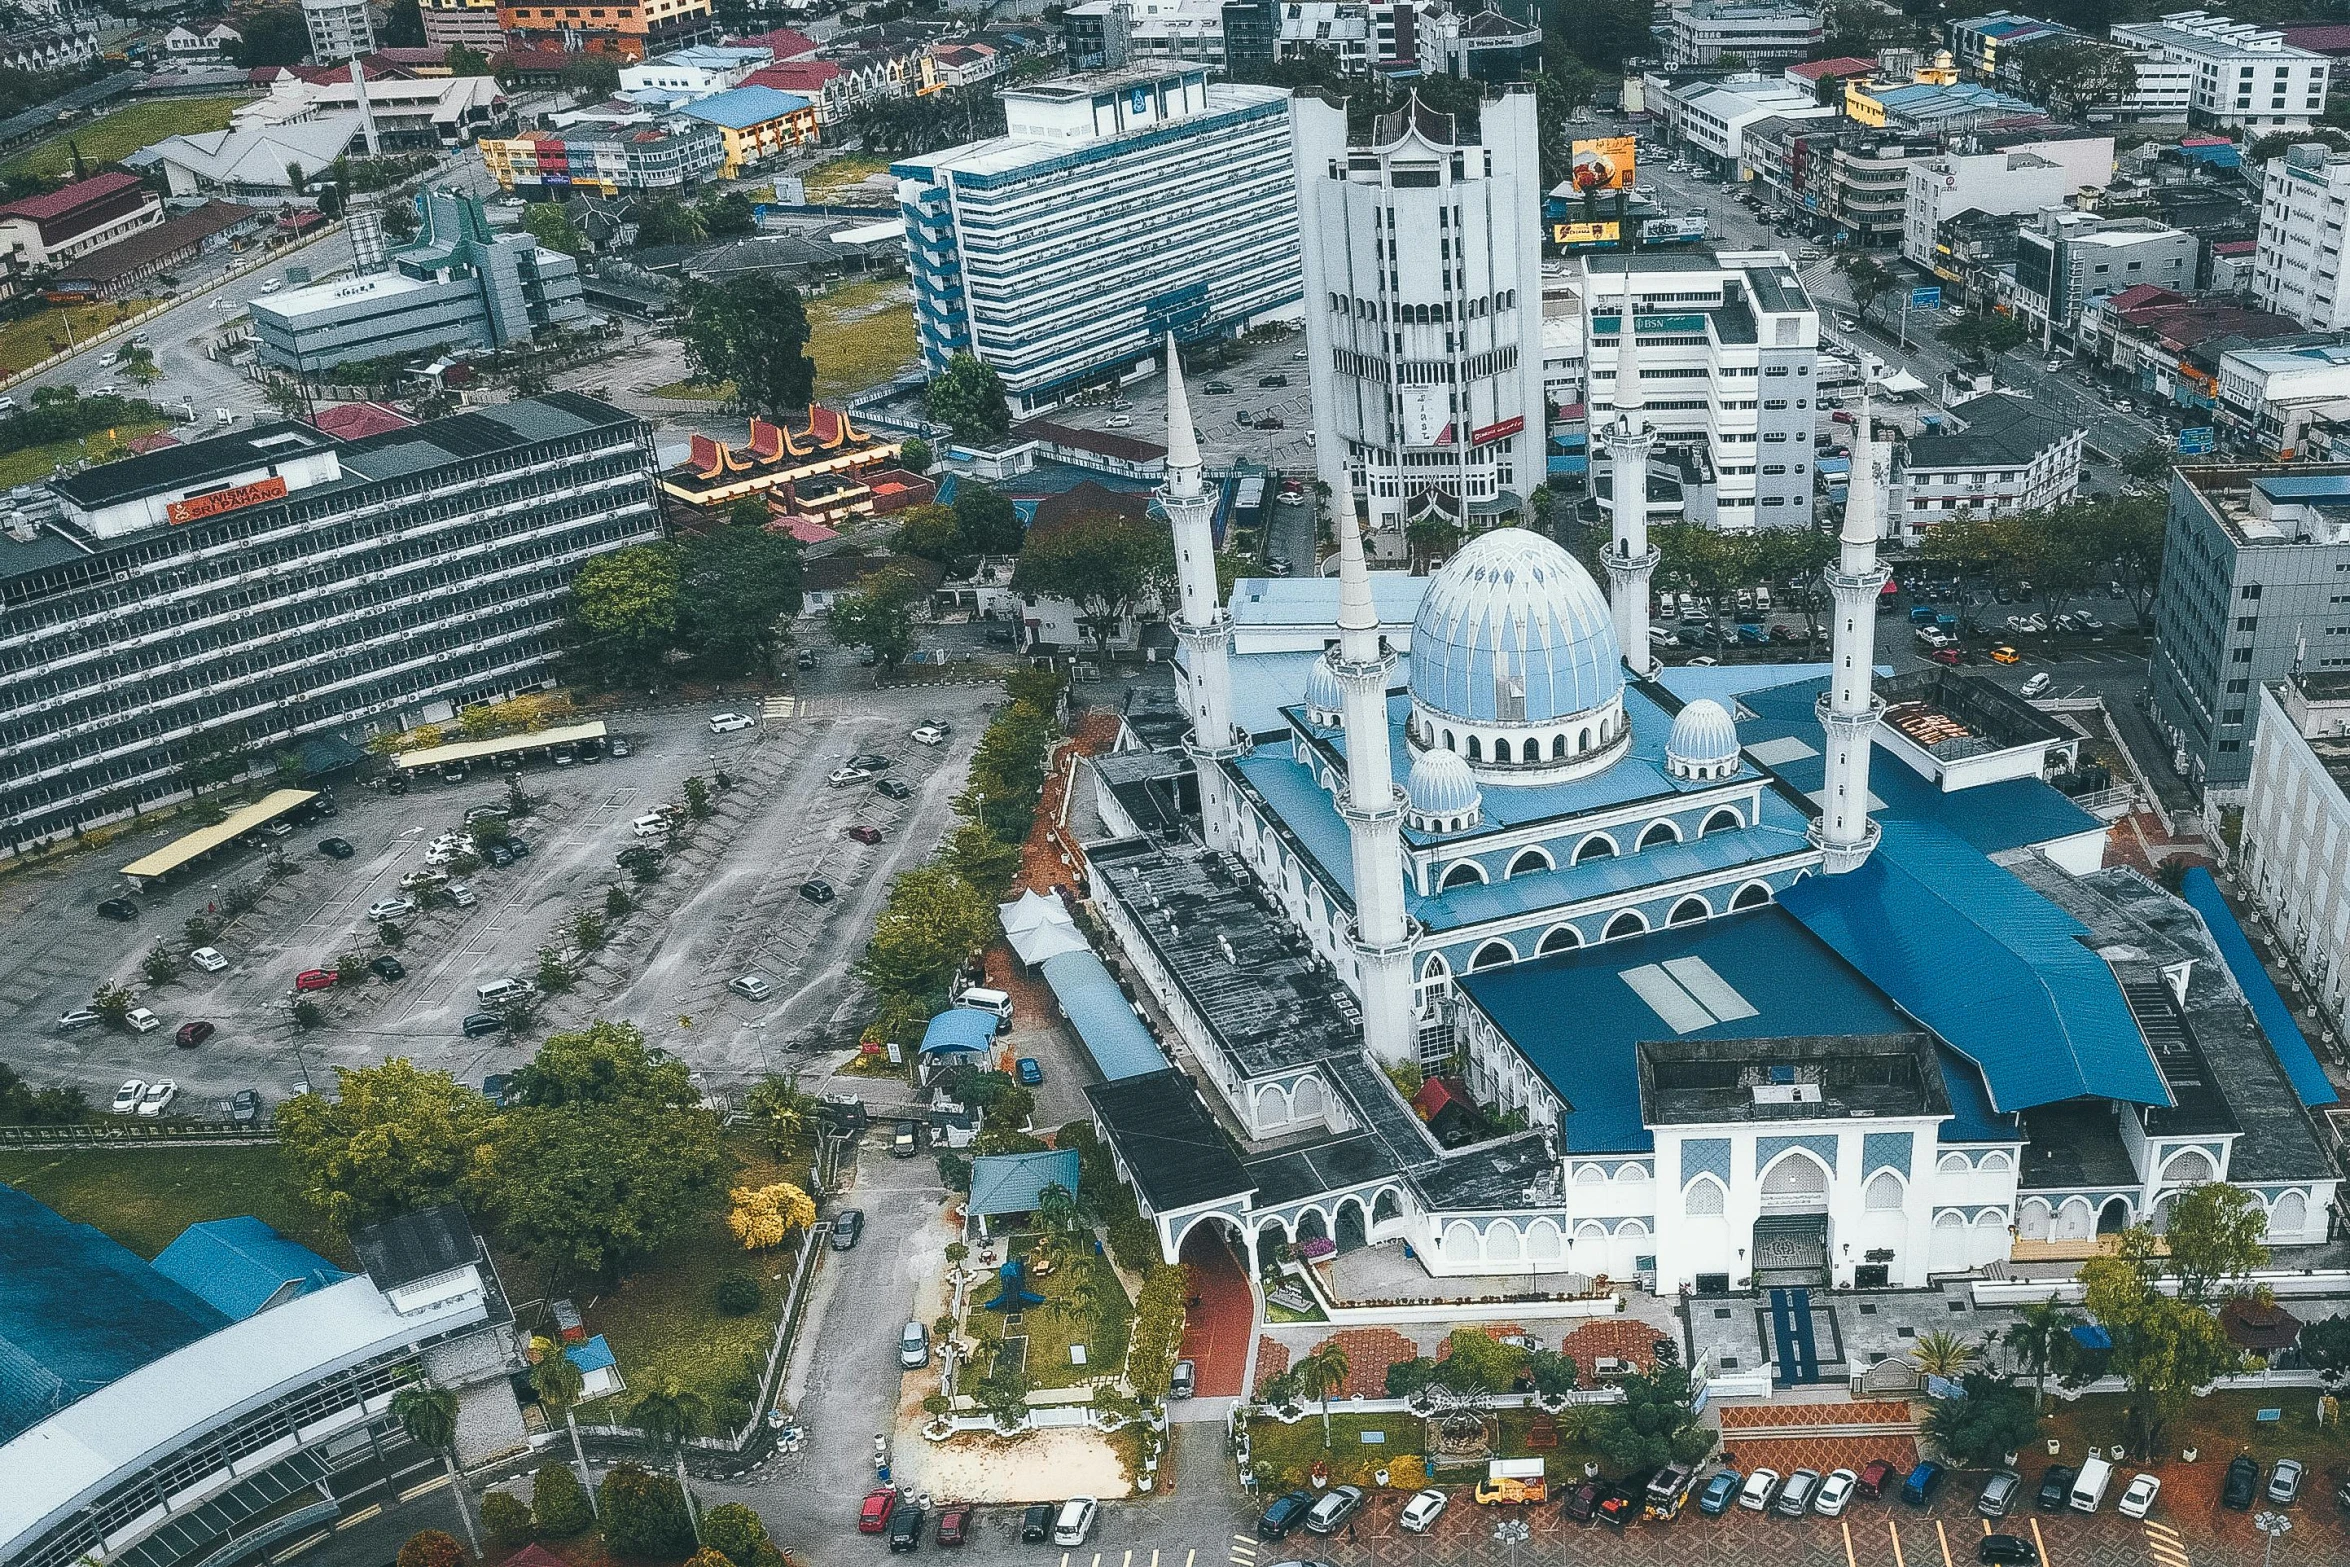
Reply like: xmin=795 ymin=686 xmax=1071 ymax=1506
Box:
xmin=1459 ymin=907 xmax=1915 ymax=1154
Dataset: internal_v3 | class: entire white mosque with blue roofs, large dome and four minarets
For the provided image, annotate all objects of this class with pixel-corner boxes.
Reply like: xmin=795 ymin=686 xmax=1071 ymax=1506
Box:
xmin=1086 ymin=300 xmax=2336 ymax=1334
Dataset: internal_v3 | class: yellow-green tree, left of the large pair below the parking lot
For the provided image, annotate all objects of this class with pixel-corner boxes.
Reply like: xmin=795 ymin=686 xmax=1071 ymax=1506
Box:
xmin=277 ymin=1055 xmax=491 ymax=1229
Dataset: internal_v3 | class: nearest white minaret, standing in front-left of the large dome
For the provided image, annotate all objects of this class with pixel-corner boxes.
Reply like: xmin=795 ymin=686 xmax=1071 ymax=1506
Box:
xmin=1325 ymin=491 xmax=1417 ymax=1064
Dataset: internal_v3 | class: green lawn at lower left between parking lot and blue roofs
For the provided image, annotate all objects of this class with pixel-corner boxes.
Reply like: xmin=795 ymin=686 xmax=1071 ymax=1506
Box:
xmin=0 ymin=1146 xmax=353 ymax=1266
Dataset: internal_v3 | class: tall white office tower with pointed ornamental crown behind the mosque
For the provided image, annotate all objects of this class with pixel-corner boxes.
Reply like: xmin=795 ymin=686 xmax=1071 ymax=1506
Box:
xmin=1293 ymin=87 xmax=1546 ymax=554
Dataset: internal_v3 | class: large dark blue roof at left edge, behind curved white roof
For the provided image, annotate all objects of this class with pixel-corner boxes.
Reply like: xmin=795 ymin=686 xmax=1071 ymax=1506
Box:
xmin=0 ymin=1186 xmax=228 ymax=1442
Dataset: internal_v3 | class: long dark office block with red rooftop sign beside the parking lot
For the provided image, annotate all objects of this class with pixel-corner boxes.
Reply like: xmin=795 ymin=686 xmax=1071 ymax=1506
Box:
xmin=0 ymin=392 xmax=660 ymax=846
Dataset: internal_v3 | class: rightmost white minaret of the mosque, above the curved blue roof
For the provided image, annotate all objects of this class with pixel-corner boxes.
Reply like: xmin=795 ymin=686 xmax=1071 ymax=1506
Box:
xmin=1812 ymin=373 xmax=1889 ymax=876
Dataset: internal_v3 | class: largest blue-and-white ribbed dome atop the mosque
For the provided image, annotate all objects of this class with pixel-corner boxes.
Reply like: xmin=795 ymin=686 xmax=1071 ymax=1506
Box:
xmin=1412 ymin=529 xmax=1624 ymax=724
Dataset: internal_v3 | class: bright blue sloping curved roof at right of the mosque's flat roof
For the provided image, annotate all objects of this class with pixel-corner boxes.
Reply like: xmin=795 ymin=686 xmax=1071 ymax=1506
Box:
xmin=1779 ymin=820 xmax=2171 ymax=1111
